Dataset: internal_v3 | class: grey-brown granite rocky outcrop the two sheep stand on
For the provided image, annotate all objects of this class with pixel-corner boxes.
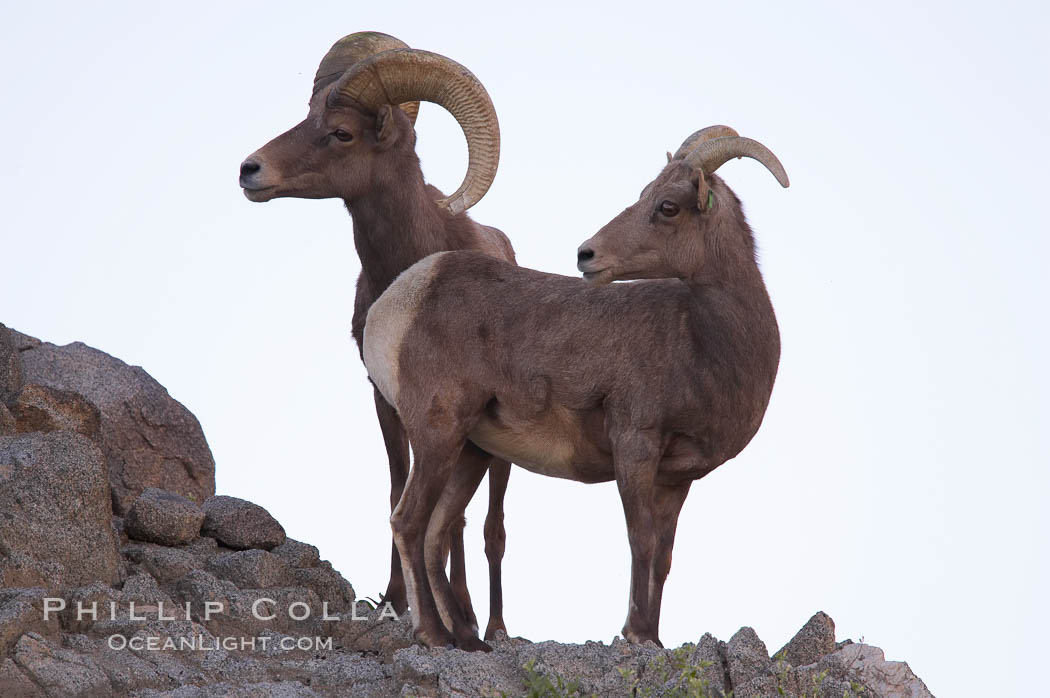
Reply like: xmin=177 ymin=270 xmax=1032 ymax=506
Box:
xmin=0 ymin=325 xmax=930 ymax=698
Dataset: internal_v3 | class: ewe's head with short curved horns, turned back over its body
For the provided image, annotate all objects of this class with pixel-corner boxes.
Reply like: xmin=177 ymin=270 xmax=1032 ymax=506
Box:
xmin=576 ymin=126 xmax=788 ymax=283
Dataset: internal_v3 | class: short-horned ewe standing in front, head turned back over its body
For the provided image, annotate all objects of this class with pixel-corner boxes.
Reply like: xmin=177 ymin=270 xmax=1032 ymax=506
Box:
xmin=364 ymin=126 xmax=788 ymax=649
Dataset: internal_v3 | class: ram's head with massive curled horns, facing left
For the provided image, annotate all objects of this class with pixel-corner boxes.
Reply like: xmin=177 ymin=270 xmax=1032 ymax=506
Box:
xmin=240 ymin=31 xmax=500 ymax=213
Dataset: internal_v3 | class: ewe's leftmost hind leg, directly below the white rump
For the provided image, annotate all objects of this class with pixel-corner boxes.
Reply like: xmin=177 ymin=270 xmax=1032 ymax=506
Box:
xmin=391 ymin=440 xmax=463 ymax=648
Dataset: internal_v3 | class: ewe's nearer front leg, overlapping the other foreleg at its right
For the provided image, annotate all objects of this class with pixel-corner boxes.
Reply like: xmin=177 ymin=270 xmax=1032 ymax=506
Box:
xmin=612 ymin=431 xmax=663 ymax=647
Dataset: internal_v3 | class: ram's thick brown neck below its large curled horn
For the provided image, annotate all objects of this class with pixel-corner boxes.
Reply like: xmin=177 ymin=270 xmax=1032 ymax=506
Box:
xmin=345 ymin=166 xmax=450 ymax=295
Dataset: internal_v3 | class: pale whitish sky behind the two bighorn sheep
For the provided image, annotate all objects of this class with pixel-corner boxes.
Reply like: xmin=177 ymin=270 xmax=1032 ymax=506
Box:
xmin=0 ymin=2 xmax=1050 ymax=696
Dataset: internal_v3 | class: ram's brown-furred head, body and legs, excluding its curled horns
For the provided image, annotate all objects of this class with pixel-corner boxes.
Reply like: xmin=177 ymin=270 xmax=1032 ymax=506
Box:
xmin=240 ymin=84 xmax=515 ymax=636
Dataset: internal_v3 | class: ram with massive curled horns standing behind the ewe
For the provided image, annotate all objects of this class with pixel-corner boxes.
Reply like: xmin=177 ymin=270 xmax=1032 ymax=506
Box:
xmin=240 ymin=31 xmax=515 ymax=637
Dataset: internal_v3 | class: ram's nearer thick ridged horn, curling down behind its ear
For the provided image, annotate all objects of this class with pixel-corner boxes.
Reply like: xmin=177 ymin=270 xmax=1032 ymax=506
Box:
xmin=329 ymin=48 xmax=500 ymax=214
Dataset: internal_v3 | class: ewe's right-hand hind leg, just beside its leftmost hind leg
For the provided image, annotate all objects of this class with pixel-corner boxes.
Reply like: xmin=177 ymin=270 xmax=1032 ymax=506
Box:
xmin=424 ymin=443 xmax=491 ymax=651
